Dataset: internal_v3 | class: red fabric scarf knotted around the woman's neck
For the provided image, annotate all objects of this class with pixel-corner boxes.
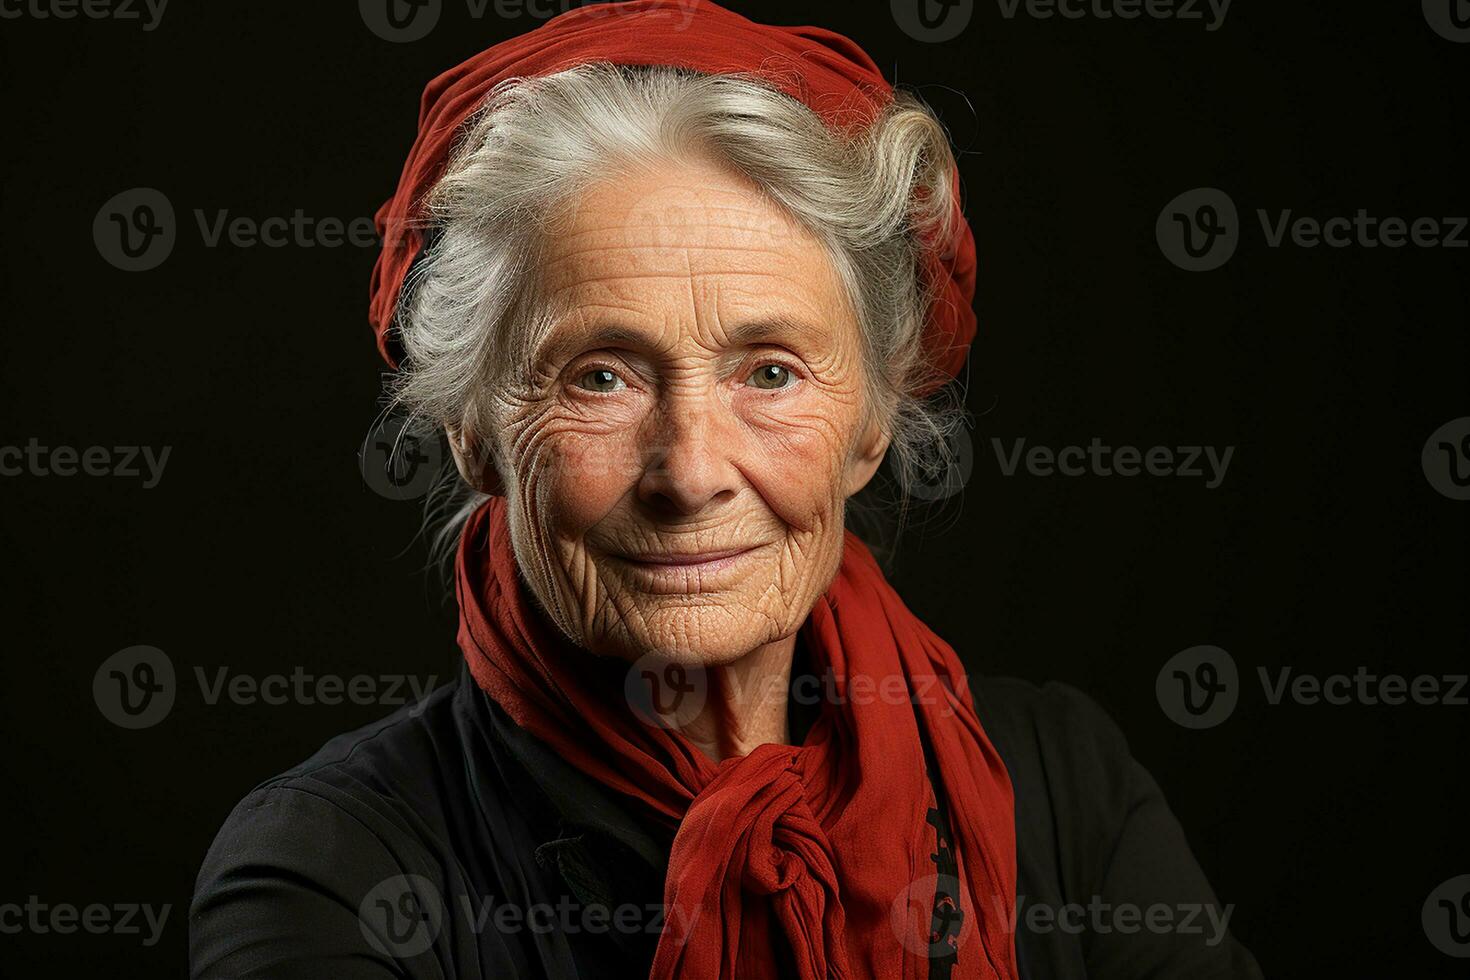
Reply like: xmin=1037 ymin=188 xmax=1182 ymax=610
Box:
xmin=459 ymin=497 xmax=1017 ymax=980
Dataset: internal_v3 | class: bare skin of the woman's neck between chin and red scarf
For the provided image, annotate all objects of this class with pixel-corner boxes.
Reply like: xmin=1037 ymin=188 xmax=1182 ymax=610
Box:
xmin=679 ymin=633 xmax=797 ymax=761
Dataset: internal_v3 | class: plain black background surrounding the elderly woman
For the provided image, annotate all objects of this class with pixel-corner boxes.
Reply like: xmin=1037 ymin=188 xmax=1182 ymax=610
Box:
xmin=0 ymin=0 xmax=1470 ymax=977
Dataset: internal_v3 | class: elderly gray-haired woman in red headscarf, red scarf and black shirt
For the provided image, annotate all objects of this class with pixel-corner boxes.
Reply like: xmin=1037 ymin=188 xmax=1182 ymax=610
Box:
xmin=190 ymin=0 xmax=1257 ymax=980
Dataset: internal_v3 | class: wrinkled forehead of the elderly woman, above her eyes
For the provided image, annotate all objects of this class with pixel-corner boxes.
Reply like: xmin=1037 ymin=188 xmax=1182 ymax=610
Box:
xmin=542 ymin=169 xmax=856 ymax=359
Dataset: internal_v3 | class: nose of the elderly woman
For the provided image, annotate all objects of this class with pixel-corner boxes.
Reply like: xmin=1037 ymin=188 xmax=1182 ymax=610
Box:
xmin=638 ymin=394 xmax=741 ymax=514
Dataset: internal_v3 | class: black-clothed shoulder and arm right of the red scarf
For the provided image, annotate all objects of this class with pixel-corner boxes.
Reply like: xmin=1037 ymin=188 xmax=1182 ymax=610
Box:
xmin=970 ymin=679 xmax=1261 ymax=980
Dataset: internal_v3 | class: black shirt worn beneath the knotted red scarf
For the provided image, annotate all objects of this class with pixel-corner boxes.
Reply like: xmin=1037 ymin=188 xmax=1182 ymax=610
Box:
xmin=190 ymin=658 xmax=1261 ymax=980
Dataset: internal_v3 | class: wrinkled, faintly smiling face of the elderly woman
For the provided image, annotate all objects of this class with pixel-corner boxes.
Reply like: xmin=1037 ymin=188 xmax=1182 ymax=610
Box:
xmin=464 ymin=163 xmax=888 ymax=666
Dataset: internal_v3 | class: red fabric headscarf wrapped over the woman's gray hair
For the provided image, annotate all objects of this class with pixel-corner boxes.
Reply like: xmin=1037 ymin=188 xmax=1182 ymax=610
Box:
xmin=369 ymin=0 xmax=976 ymax=390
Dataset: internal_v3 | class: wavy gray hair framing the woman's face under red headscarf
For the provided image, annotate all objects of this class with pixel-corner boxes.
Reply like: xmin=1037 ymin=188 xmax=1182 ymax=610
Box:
xmin=390 ymin=63 xmax=966 ymax=570
